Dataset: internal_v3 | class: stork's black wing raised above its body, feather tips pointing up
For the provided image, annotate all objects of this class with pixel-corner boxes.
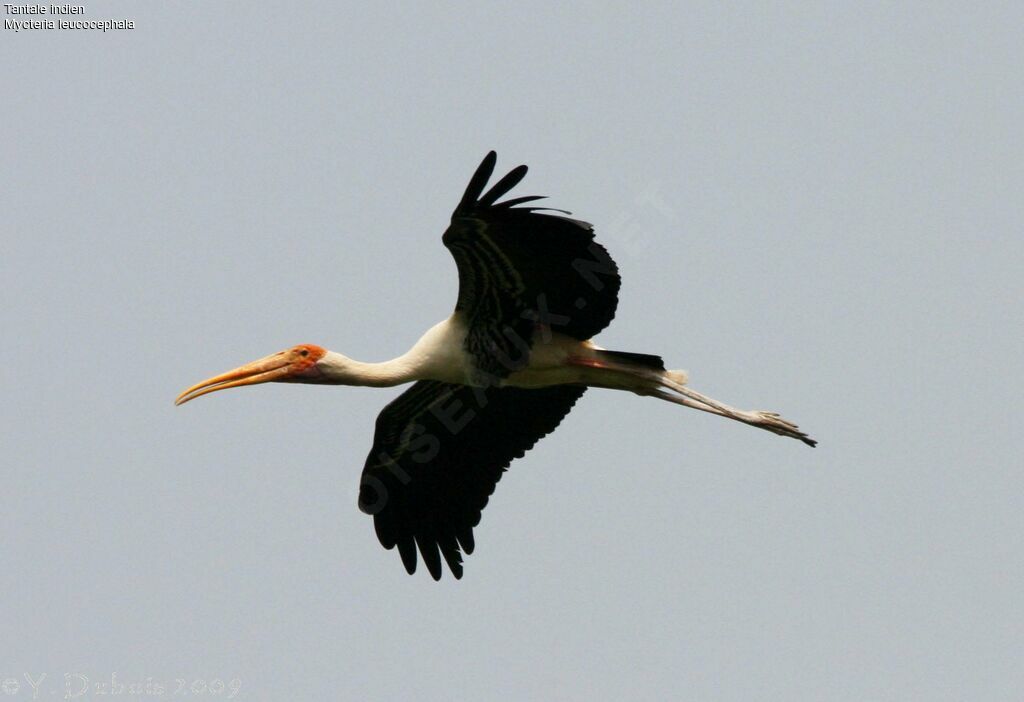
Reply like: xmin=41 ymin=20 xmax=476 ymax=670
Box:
xmin=442 ymin=151 xmax=620 ymax=378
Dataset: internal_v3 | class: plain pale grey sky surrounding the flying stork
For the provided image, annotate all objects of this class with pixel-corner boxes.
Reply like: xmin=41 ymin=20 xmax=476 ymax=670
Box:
xmin=0 ymin=1 xmax=1024 ymax=702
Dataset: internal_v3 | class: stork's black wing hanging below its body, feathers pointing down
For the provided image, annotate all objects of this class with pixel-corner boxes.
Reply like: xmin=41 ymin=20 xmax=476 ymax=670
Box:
xmin=359 ymin=381 xmax=586 ymax=580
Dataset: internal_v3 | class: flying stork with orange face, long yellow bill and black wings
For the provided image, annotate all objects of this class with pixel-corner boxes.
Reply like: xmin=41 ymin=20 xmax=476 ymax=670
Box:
xmin=175 ymin=151 xmax=816 ymax=580
